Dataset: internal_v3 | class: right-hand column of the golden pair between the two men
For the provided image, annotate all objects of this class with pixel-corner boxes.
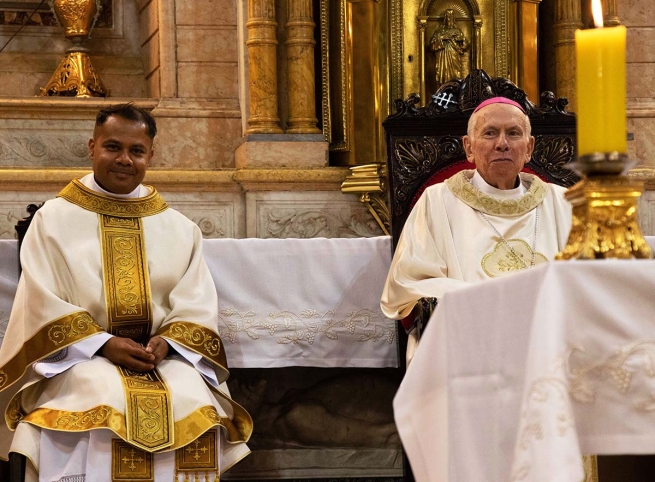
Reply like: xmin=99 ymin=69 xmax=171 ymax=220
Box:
xmin=286 ymin=0 xmax=321 ymax=134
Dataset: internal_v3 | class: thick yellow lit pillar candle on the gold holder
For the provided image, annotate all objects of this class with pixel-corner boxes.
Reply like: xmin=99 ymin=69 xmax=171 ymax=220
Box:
xmin=575 ymin=25 xmax=627 ymax=156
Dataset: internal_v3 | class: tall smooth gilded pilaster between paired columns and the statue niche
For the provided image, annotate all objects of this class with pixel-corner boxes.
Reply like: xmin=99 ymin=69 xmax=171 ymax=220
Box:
xmin=321 ymin=0 xmax=390 ymax=165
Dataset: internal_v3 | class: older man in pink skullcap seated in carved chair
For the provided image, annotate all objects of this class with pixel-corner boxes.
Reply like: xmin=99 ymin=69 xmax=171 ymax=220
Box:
xmin=381 ymin=97 xmax=571 ymax=360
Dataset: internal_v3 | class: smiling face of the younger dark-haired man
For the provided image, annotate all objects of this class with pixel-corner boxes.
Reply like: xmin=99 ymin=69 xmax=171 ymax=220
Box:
xmin=89 ymin=115 xmax=154 ymax=194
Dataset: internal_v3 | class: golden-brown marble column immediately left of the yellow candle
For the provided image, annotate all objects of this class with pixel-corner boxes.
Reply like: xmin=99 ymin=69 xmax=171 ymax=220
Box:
xmin=553 ymin=0 xmax=582 ymax=112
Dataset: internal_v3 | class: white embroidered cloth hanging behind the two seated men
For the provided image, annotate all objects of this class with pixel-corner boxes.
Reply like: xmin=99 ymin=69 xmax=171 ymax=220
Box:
xmin=0 ymin=237 xmax=398 ymax=368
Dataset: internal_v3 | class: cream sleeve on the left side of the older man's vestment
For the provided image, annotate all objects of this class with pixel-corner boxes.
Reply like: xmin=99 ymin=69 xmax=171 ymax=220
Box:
xmin=380 ymin=186 xmax=469 ymax=319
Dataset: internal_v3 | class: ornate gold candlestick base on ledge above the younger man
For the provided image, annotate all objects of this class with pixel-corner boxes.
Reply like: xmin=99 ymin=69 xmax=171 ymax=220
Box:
xmin=41 ymin=0 xmax=109 ymax=97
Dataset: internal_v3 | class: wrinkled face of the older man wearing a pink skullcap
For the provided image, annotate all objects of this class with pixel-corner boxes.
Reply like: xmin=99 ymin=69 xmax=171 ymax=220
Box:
xmin=463 ymin=104 xmax=534 ymax=189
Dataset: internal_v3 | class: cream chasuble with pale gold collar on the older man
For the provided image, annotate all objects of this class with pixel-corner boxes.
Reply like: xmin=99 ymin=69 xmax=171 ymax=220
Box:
xmin=381 ymin=170 xmax=571 ymax=319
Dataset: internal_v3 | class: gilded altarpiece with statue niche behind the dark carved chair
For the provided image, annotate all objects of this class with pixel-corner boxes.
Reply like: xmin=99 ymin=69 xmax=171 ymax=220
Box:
xmin=326 ymin=0 xmax=540 ymax=166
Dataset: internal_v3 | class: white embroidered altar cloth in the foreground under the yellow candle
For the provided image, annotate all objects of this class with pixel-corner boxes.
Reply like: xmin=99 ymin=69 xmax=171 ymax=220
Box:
xmin=394 ymin=260 xmax=655 ymax=482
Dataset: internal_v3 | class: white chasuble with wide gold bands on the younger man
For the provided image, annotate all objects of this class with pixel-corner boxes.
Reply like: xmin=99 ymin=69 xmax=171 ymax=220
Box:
xmin=0 ymin=176 xmax=252 ymax=474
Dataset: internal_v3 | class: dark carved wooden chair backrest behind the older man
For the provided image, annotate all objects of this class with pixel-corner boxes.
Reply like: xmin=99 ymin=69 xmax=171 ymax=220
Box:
xmin=383 ymin=70 xmax=578 ymax=247
